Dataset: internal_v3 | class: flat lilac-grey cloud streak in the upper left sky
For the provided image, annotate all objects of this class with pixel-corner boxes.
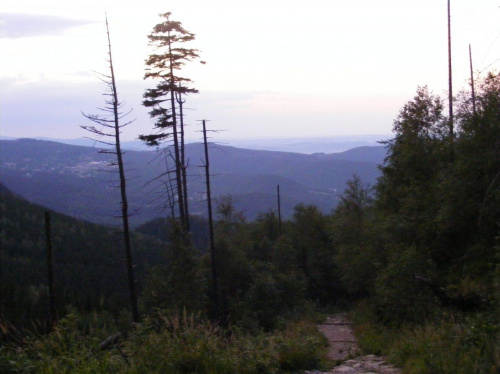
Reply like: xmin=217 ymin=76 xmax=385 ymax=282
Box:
xmin=0 ymin=13 xmax=93 ymax=39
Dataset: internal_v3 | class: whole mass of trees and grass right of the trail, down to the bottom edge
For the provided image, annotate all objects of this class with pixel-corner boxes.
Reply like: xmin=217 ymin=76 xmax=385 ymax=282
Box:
xmin=348 ymin=73 xmax=500 ymax=373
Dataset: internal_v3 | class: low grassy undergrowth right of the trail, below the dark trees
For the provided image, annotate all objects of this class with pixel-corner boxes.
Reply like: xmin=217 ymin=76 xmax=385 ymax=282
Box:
xmin=352 ymin=308 xmax=500 ymax=374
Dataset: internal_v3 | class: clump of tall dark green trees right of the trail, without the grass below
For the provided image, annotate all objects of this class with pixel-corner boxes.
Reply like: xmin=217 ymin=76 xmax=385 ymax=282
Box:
xmin=368 ymin=74 xmax=500 ymax=322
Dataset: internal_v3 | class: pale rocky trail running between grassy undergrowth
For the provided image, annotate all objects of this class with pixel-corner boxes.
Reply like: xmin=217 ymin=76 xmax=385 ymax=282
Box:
xmin=305 ymin=314 xmax=401 ymax=374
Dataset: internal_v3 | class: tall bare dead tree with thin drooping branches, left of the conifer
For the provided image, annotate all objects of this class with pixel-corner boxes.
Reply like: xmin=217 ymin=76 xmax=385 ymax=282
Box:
xmin=81 ymin=17 xmax=139 ymax=322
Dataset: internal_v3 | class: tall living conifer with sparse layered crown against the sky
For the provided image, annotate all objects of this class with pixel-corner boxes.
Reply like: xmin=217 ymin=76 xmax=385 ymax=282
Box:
xmin=139 ymin=12 xmax=198 ymax=230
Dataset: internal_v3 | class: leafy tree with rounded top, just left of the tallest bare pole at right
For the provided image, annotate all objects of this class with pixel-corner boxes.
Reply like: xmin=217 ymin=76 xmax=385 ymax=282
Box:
xmin=377 ymin=88 xmax=449 ymax=251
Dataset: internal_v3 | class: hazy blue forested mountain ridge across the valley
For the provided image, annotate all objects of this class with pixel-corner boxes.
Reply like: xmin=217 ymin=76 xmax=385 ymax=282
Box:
xmin=0 ymin=139 xmax=385 ymax=225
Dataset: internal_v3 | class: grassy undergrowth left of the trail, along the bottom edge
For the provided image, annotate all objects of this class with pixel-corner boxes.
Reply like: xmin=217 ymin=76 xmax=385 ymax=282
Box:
xmin=0 ymin=313 xmax=328 ymax=374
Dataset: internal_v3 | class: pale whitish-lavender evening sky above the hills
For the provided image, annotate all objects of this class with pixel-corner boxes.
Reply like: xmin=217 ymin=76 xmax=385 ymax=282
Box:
xmin=0 ymin=0 xmax=500 ymax=140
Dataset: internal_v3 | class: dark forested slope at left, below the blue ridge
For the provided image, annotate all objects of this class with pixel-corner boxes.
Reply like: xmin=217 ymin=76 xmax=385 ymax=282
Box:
xmin=0 ymin=188 xmax=158 ymax=326
